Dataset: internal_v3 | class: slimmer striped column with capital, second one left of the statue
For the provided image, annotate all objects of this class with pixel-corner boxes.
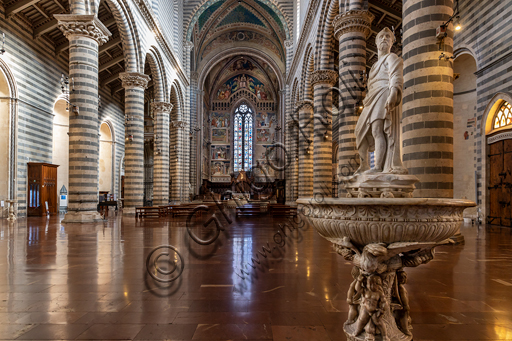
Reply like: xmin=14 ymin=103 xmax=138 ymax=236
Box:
xmin=311 ymin=70 xmax=338 ymax=200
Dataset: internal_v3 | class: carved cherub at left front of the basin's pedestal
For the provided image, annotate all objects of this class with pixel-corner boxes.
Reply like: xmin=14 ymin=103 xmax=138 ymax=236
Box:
xmin=354 ymin=275 xmax=389 ymax=341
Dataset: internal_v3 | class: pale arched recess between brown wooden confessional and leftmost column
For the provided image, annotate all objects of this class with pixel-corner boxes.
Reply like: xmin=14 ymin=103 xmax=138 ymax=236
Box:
xmin=52 ymin=98 xmax=69 ymax=210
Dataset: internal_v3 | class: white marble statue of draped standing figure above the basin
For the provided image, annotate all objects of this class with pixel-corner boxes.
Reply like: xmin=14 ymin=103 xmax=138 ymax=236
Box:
xmin=355 ymin=27 xmax=407 ymax=174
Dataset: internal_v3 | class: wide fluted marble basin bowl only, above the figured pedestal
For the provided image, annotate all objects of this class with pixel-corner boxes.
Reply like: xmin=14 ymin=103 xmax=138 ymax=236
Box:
xmin=297 ymin=198 xmax=475 ymax=246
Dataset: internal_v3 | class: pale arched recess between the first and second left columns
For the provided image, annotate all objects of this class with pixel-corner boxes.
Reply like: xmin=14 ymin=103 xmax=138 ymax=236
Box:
xmin=99 ymin=122 xmax=114 ymax=199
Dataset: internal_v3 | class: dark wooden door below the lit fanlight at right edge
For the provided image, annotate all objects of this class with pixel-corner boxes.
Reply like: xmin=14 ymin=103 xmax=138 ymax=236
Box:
xmin=487 ymin=140 xmax=512 ymax=227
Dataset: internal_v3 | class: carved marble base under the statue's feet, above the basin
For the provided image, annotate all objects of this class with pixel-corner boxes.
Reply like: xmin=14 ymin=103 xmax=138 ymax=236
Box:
xmin=340 ymin=173 xmax=420 ymax=198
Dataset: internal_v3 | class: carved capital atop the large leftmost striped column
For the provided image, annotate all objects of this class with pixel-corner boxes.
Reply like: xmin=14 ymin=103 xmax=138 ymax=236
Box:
xmin=53 ymin=14 xmax=112 ymax=46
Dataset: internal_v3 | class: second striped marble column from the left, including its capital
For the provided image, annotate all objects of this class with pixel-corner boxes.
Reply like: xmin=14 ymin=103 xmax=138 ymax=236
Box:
xmin=119 ymin=72 xmax=150 ymax=214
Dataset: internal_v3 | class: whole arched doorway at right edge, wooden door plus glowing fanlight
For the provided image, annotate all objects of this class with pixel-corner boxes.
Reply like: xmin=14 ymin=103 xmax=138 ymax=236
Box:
xmin=485 ymin=95 xmax=512 ymax=227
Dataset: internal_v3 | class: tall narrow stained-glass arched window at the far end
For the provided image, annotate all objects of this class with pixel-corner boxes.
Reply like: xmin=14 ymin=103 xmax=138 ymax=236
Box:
xmin=233 ymin=104 xmax=252 ymax=172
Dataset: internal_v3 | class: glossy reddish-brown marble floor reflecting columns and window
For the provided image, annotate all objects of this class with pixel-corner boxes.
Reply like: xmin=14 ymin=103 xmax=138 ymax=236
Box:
xmin=0 ymin=212 xmax=512 ymax=341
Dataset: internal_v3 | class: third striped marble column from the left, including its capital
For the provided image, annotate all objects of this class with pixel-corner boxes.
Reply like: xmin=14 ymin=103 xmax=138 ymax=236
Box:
xmin=151 ymin=102 xmax=172 ymax=206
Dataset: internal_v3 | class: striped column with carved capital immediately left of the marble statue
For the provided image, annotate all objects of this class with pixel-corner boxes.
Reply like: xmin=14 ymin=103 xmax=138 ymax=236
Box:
xmin=333 ymin=7 xmax=374 ymax=197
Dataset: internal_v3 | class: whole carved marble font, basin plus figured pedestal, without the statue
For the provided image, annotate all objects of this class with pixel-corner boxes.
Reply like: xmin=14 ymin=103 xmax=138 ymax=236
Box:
xmin=297 ymin=197 xmax=475 ymax=341
